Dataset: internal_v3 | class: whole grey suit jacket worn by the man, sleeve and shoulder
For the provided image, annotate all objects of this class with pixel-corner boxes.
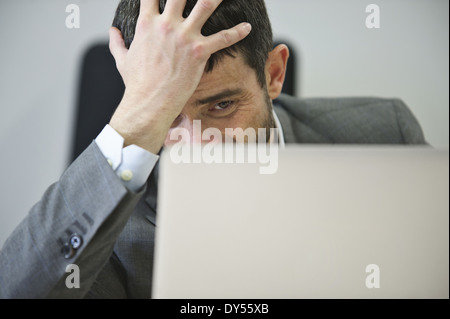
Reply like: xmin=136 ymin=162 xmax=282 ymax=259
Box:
xmin=0 ymin=95 xmax=425 ymax=298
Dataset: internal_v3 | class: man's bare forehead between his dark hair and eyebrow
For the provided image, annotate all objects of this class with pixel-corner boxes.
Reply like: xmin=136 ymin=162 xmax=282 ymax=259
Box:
xmin=194 ymin=54 xmax=257 ymax=98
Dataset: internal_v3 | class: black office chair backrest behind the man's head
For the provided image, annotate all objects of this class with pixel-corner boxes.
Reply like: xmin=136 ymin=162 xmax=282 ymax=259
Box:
xmin=70 ymin=42 xmax=296 ymax=162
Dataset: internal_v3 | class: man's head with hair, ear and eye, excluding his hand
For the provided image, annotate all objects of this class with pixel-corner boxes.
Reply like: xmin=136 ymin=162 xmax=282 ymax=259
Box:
xmin=113 ymin=0 xmax=289 ymax=142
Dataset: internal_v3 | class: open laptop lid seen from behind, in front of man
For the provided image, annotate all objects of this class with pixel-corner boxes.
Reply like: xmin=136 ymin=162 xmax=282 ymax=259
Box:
xmin=152 ymin=145 xmax=449 ymax=299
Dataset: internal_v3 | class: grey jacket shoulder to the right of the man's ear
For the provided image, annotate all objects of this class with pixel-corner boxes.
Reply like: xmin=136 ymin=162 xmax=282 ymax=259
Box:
xmin=275 ymin=94 xmax=426 ymax=144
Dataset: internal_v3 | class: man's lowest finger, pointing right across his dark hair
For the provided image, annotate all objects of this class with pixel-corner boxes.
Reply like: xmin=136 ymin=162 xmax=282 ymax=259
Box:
xmin=205 ymin=22 xmax=252 ymax=54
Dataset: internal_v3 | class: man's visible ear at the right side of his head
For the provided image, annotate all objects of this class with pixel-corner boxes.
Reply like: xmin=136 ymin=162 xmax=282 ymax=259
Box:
xmin=266 ymin=44 xmax=289 ymax=100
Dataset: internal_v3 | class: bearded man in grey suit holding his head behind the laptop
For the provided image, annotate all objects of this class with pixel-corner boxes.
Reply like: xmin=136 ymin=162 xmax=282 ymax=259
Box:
xmin=0 ymin=0 xmax=425 ymax=298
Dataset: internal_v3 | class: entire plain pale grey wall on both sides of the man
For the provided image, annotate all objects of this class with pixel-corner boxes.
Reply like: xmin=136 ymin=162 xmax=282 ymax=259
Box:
xmin=0 ymin=0 xmax=449 ymax=245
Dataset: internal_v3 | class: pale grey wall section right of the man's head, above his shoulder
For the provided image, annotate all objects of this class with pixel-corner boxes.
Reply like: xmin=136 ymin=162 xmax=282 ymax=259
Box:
xmin=267 ymin=0 xmax=449 ymax=146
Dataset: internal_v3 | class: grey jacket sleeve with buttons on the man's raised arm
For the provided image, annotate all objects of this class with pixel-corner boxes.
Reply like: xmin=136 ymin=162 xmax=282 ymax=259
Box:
xmin=0 ymin=142 xmax=149 ymax=298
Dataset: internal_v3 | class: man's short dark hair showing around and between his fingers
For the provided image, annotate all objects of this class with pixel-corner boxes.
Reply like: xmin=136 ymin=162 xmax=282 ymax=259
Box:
xmin=113 ymin=0 xmax=273 ymax=87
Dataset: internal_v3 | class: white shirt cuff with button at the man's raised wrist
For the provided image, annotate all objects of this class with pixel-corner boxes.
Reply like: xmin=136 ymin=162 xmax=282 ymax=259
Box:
xmin=95 ymin=125 xmax=159 ymax=192
